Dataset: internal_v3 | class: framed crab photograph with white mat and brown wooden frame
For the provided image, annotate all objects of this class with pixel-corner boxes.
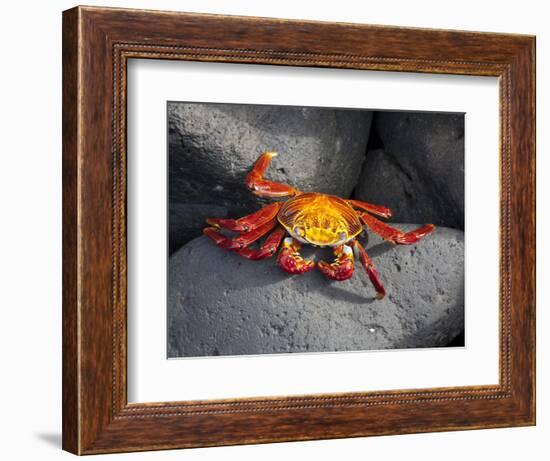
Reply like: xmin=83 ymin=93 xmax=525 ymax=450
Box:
xmin=63 ymin=7 xmax=535 ymax=454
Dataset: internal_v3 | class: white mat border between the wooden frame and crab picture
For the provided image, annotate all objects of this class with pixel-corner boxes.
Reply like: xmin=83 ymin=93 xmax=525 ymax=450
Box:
xmin=127 ymin=59 xmax=499 ymax=402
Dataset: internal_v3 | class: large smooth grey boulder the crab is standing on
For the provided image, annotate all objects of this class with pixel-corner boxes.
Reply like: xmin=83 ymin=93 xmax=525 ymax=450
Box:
xmin=168 ymin=224 xmax=464 ymax=357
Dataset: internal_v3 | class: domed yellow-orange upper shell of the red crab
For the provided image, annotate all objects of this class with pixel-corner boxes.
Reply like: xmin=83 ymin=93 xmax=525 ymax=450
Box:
xmin=277 ymin=193 xmax=362 ymax=246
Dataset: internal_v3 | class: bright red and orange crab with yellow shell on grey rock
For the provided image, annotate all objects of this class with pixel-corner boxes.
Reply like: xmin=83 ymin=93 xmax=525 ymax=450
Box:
xmin=203 ymin=152 xmax=435 ymax=299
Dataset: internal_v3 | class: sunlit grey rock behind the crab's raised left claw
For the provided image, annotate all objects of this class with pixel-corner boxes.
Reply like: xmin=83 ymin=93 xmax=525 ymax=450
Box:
xmin=168 ymin=103 xmax=372 ymax=252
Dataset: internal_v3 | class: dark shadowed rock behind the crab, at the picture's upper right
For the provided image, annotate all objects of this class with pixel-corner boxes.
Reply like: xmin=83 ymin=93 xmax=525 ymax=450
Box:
xmin=354 ymin=112 xmax=464 ymax=229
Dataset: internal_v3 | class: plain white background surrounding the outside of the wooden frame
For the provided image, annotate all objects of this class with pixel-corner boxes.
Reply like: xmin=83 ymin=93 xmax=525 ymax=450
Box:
xmin=0 ymin=0 xmax=550 ymax=461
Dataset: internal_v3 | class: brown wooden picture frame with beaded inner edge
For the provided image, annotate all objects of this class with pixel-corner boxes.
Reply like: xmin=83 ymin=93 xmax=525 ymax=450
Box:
xmin=63 ymin=7 xmax=535 ymax=454
